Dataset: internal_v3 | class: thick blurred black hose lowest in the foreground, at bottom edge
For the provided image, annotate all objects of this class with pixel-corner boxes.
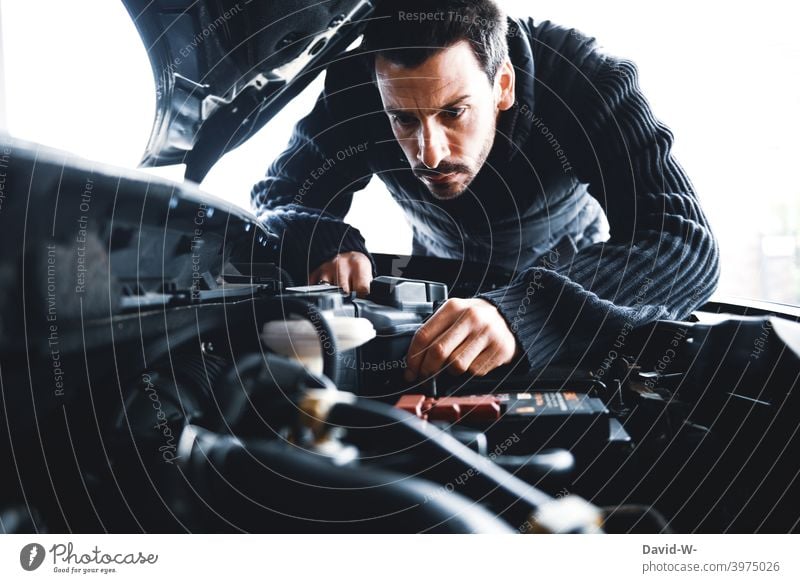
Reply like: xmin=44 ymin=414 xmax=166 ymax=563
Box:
xmin=179 ymin=426 xmax=513 ymax=533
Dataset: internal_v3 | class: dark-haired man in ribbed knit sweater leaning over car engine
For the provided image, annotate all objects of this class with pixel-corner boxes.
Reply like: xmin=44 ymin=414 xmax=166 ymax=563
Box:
xmin=252 ymin=0 xmax=719 ymax=381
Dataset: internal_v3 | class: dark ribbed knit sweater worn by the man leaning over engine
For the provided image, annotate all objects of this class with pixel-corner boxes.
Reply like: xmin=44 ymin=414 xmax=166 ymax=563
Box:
xmin=252 ymin=20 xmax=719 ymax=367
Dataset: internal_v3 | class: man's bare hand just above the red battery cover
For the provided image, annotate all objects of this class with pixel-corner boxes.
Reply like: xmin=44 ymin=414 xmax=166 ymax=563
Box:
xmin=405 ymin=298 xmax=519 ymax=382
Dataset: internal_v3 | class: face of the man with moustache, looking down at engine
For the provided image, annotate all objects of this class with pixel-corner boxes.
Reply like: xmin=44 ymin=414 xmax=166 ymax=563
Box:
xmin=375 ymin=41 xmax=514 ymax=200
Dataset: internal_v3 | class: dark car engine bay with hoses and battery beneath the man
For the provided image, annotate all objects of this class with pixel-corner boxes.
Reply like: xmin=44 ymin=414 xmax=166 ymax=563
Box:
xmin=0 ymin=141 xmax=800 ymax=533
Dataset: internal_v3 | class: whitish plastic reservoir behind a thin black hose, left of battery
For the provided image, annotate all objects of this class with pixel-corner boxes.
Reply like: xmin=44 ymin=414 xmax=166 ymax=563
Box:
xmin=261 ymin=311 xmax=375 ymax=374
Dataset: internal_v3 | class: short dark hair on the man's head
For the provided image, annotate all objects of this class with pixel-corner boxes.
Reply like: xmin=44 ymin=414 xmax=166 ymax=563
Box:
xmin=362 ymin=0 xmax=508 ymax=82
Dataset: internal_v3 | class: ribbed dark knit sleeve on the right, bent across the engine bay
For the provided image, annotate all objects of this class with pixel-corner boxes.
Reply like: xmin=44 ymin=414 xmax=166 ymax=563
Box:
xmin=480 ymin=56 xmax=719 ymax=367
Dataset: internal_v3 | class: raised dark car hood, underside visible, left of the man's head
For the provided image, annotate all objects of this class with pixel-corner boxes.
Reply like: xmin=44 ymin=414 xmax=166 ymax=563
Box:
xmin=123 ymin=0 xmax=373 ymax=182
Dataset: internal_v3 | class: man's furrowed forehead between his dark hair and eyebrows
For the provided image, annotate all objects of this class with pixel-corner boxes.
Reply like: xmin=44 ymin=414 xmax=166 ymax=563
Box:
xmin=375 ymin=41 xmax=489 ymax=109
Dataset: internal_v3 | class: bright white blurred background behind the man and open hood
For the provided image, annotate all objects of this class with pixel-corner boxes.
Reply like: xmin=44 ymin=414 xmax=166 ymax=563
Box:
xmin=0 ymin=0 xmax=800 ymax=304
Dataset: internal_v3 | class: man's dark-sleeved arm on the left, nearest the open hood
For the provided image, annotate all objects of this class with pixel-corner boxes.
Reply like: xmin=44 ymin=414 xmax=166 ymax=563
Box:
xmin=251 ymin=64 xmax=372 ymax=283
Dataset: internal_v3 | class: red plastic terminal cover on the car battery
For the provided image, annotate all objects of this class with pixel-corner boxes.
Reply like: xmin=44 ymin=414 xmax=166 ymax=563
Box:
xmin=395 ymin=395 xmax=501 ymax=423
